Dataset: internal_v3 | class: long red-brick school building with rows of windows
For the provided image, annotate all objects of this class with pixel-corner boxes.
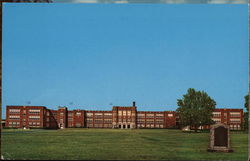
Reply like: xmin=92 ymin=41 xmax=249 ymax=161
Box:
xmin=6 ymin=102 xmax=243 ymax=130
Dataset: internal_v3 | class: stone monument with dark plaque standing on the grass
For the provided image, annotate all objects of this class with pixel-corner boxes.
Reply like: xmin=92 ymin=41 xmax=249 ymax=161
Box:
xmin=208 ymin=123 xmax=233 ymax=152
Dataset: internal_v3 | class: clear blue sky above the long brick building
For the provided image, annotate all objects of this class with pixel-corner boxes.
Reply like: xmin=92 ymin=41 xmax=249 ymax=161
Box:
xmin=2 ymin=4 xmax=248 ymax=118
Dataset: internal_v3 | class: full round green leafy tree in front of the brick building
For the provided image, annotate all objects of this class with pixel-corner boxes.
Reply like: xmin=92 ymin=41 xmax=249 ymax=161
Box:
xmin=177 ymin=88 xmax=216 ymax=132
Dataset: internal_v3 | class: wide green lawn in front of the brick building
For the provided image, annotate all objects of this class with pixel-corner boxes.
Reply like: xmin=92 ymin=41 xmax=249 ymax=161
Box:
xmin=1 ymin=129 xmax=248 ymax=161
